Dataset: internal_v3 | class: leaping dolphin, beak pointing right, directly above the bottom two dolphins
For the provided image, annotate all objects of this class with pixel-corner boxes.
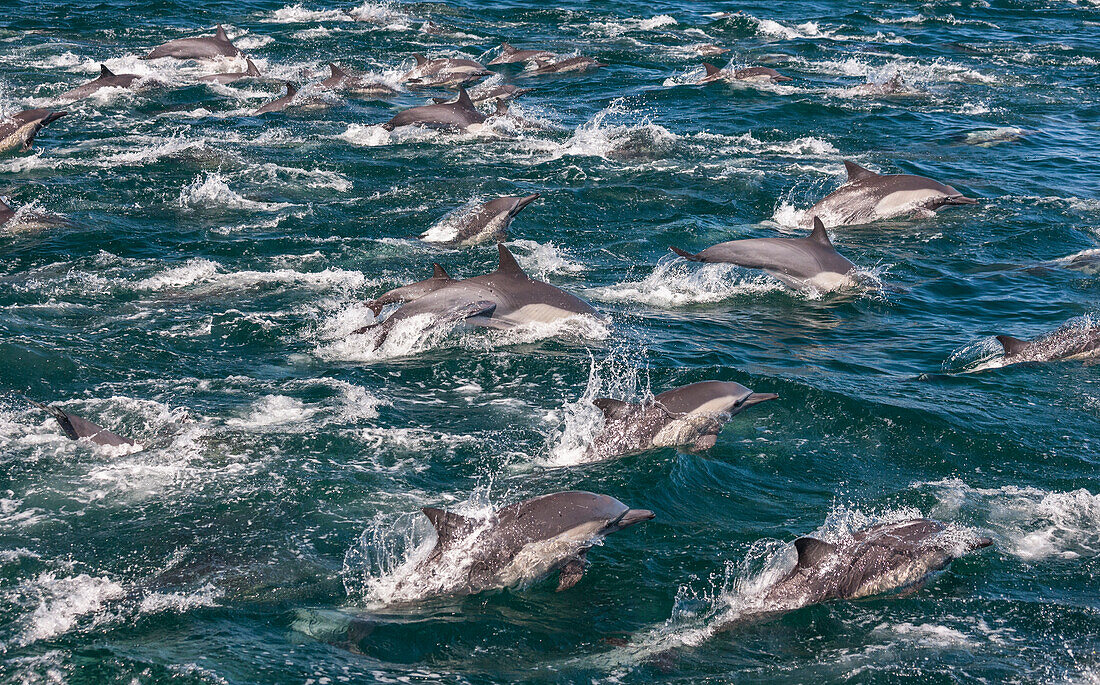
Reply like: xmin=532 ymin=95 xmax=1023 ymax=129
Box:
xmin=589 ymin=380 xmax=779 ymax=458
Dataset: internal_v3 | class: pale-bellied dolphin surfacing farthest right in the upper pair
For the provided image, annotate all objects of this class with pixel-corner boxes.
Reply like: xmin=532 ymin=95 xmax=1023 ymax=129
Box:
xmin=805 ymin=161 xmax=978 ymax=225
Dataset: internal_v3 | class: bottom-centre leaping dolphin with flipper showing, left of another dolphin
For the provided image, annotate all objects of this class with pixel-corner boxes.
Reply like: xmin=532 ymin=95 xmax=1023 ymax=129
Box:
xmin=417 ymin=491 xmax=655 ymax=595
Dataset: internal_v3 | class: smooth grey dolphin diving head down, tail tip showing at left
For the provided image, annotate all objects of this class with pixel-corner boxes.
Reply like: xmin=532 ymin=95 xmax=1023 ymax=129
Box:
xmin=672 ymin=217 xmax=856 ymax=290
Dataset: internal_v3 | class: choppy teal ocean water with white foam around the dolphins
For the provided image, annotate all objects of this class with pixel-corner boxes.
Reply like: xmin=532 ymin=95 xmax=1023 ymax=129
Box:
xmin=0 ymin=0 xmax=1100 ymax=683
